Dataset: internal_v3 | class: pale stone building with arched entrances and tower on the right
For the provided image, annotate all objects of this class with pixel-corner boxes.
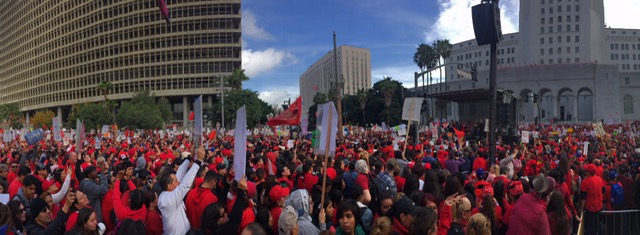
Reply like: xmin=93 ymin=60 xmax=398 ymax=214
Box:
xmin=418 ymin=0 xmax=640 ymax=123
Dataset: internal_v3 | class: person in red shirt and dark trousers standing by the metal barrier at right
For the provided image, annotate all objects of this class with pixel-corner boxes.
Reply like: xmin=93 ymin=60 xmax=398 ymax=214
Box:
xmin=578 ymin=164 xmax=604 ymax=235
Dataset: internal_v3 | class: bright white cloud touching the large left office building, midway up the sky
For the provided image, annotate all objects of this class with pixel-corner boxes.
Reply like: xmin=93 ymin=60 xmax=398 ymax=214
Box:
xmin=242 ymin=48 xmax=298 ymax=77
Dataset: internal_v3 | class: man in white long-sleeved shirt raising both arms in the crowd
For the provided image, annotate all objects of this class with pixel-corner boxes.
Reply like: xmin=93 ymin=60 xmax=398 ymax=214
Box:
xmin=158 ymin=146 xmax=205 ymax=235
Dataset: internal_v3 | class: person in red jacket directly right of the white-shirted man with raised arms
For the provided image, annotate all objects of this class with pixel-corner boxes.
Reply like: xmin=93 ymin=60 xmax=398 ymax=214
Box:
xmin=185 ymin=171 xmax=218 ymax=228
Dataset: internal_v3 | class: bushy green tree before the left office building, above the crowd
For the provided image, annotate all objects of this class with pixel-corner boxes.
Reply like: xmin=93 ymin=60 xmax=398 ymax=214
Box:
xmin=116 ymin=90 xmax=170 ymax=129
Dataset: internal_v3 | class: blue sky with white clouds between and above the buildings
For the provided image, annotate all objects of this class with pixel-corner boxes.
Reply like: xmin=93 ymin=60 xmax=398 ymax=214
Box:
xmin=242 ymin=0 xmax=640 ymax=104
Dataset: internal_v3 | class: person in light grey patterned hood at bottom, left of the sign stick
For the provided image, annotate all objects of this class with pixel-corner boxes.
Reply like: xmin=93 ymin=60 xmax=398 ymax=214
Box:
xmin=285 ymin=189 xmax=320 ymax=234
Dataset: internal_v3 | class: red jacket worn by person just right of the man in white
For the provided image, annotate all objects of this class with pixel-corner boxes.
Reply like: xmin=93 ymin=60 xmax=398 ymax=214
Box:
xmin=184 ymin=187 xmax=218 ymax=228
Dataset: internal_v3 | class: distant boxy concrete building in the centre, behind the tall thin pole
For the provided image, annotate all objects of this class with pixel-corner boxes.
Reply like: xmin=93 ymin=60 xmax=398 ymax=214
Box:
xmin=300 ymin=45 xmax=372 ymax=118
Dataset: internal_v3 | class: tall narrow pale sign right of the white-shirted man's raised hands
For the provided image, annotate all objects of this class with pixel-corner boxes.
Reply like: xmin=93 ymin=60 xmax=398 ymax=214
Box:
xmin=233 ymin=105 xmax=247 ymax=181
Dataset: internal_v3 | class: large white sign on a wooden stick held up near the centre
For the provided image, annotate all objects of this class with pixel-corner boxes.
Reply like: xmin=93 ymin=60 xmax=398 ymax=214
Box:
xmin=314 ymin=102 xmax=338 ymax=155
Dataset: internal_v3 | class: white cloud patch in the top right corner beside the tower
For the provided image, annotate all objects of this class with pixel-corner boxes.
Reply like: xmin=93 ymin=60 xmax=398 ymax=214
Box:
xmin=604 ymin=0 xmax=640 ymax=29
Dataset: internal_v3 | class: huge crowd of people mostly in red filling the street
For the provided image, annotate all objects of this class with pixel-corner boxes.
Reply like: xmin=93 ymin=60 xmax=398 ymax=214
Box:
xmin=0 ymin=122 xmax=640 ymax=235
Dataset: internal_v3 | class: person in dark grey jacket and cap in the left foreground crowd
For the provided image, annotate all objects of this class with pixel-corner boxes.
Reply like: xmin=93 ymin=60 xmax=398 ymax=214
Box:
xmin=80 ymin=163 xmax=109 ymax=222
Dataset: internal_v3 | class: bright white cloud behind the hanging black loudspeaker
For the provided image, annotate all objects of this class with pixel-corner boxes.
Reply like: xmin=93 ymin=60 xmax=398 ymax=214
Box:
xmin=425 ymin=0 xmax=520 ymax=43
